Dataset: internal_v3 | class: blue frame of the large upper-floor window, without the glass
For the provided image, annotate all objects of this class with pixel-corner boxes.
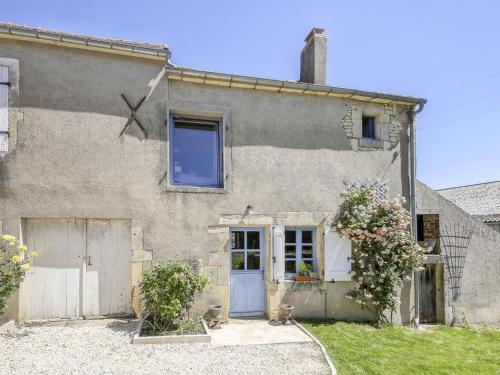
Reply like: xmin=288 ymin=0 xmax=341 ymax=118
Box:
xmin=168 ymin=114 xmax=224 ymax=189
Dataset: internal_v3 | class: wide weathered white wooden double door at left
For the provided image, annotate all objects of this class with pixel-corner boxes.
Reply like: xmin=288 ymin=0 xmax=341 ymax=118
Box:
xmin=24 ymin=219 xmax=131 ymax=320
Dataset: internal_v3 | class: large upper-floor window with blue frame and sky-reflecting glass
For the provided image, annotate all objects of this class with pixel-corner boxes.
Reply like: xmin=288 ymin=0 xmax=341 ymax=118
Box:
xmin=169 ymin=116 xmax=223 ymax=187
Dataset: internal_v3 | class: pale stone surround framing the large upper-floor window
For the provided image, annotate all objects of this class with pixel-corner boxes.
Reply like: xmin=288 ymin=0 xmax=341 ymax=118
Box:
xmin=162 ymin=100 xmax=232 ymax=194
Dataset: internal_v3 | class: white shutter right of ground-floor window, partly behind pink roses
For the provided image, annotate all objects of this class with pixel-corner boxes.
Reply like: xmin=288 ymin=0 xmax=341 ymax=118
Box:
xmin=324 ymin=227 xmax=351 ymax=281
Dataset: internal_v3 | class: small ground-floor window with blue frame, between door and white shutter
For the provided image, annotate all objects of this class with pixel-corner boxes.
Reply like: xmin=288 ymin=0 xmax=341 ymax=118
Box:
xmin=285 ymin=227 xmax=316 ymax=278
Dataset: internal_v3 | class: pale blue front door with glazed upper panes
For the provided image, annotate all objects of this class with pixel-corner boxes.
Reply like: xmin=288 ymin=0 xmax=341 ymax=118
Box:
xmin=229 ymin=228 xmax=266 ymax=316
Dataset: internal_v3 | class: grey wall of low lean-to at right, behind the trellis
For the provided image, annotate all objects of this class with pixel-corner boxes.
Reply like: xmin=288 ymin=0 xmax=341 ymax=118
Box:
xmin=417 ymin=183 xmax=500 ymax=324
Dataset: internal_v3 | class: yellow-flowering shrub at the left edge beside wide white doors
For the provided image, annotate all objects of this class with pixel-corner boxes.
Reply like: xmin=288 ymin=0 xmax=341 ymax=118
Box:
xmin=0 ymin=234 xmax=36 ymax=314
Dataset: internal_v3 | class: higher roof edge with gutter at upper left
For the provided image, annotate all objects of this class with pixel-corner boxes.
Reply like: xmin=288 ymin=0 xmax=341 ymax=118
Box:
xmin=0 ymin=22 xmax=170 ymax=60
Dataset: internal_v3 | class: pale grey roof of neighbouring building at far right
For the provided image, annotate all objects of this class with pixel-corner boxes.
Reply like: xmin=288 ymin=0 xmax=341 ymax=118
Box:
xmin=437 ymin=181 xmax=500 ymax=221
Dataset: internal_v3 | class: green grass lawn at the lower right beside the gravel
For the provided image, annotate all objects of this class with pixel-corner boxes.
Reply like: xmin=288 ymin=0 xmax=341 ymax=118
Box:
xmin=303 ymin=322 xmax=500 ymax=375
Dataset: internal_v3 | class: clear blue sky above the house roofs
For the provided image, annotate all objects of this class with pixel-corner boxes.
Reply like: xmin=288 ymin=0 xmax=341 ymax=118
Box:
xmin=0 ymin=0 xmax=500 ymax=188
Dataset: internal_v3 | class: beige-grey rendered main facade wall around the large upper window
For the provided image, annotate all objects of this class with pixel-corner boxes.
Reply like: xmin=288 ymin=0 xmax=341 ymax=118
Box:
xmin=0 ymin=40 xmax=414 ymax=317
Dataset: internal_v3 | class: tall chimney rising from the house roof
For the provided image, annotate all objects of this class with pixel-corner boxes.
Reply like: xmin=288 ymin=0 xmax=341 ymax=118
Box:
xmin=300 ymin=27 xmax=326 ymax=85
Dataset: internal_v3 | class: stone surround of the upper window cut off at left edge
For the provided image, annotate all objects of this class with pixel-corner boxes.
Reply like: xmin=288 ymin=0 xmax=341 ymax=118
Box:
xmin=0 ymin=57 xmax=23 ymax=156
